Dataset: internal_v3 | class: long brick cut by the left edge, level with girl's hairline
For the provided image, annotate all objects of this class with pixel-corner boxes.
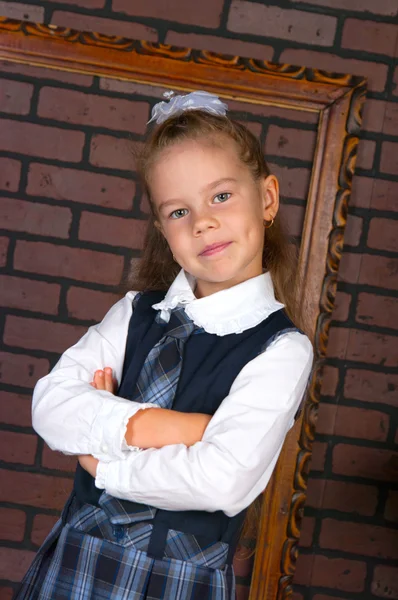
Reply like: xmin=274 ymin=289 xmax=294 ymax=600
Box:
xmin=0 ymin=119 xmax=84 ymax=162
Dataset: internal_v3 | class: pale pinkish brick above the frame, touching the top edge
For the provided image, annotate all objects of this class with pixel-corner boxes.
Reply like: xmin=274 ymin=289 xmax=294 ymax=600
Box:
xmin=227 ymin=0 xmax=337 ymax=46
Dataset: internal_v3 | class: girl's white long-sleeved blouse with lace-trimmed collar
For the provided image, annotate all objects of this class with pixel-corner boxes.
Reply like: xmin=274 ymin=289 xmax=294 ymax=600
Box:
xmin=32 ymin=270 xmax=313 ymax=516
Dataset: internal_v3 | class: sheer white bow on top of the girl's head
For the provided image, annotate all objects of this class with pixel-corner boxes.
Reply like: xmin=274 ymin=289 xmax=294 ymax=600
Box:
xmin=148 ymin=91 xmax=228 ymax=125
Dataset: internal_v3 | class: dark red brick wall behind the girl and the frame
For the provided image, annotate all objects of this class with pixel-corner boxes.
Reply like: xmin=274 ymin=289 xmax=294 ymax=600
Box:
xmin=0 ymin=0 xmax=398 ymax=600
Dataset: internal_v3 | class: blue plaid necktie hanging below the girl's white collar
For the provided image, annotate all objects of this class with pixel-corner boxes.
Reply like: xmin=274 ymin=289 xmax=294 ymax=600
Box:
xmin=132 ymin=308 xmax=199 ymax=408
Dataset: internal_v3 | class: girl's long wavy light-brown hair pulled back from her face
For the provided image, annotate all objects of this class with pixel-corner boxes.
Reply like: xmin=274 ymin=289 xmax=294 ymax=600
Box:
xmin=126 ymin=110 xmax=306 ymax=558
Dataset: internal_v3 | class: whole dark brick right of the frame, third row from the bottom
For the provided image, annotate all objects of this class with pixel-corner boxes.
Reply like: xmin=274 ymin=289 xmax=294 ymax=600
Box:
xmin=306 ymin=478 xmax=378 ymax=517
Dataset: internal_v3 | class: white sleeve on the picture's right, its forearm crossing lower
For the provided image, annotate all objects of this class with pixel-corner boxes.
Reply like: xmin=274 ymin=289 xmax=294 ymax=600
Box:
xmin=96 ymin=332 xmax=313 ymax=516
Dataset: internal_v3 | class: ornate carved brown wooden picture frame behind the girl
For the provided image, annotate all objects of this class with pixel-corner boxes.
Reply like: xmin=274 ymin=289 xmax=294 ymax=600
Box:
xmin=0 ymin=18 xmax=366 ymax=600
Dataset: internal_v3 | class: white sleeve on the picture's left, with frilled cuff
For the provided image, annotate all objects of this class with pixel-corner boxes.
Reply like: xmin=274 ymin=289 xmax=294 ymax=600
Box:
xmin=32 ymin=292 xmax=160 ymax=462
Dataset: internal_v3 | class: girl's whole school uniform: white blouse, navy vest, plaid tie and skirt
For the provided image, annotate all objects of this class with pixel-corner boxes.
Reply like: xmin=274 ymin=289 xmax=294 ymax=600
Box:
xmin=15 ymin=270 xmax=313 ymax=600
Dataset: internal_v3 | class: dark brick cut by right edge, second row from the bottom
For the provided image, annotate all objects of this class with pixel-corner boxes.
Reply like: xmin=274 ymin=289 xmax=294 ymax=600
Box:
xmin=314 ymin=519 xmax=398 ymax=560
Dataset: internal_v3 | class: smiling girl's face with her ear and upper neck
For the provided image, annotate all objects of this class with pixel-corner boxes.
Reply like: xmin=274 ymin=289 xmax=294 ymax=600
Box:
xmin=149 ymin=138 xmax=279 ymax=297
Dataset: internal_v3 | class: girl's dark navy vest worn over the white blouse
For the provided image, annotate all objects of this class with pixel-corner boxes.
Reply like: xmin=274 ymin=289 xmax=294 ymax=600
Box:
xmin=74 ymin=292 xmax=303 ymax=563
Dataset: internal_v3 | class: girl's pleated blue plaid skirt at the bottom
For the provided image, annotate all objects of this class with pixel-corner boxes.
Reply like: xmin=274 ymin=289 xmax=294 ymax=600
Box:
xmin=14 ymin=492 xmax=236 ymax=600
